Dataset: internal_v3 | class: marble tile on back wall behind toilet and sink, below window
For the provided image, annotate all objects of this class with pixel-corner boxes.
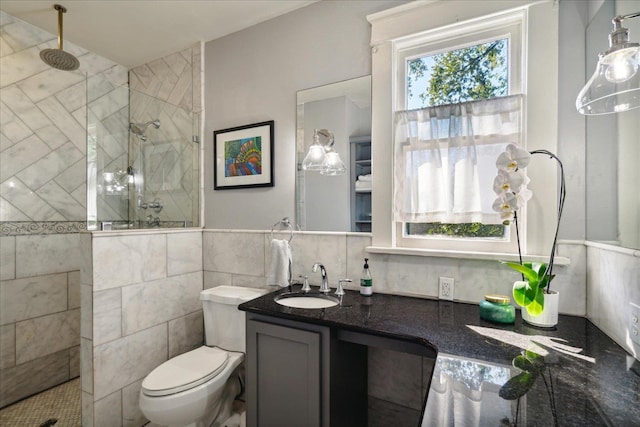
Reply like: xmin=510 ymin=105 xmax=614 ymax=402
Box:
xmin=203 ymin=230 xmax=586 ymax=316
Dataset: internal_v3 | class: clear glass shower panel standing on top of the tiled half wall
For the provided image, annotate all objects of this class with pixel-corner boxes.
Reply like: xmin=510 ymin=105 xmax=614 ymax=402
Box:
xmin=87 ymin=76 xmax=199 ymax=230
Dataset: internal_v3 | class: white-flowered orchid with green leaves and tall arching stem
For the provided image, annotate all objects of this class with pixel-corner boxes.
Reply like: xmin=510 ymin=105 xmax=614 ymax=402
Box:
xmin=493 ymin=144 xmax=566 ymax=316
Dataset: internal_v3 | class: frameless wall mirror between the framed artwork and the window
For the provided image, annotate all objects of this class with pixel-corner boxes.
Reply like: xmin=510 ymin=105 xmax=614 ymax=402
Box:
xmin=296 ymin=76 xmax=371 ymax=232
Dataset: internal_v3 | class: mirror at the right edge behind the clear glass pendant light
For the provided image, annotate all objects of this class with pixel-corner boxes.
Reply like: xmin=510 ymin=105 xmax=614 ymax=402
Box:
xmin=585 ymin=1 xmax=640 ymax=249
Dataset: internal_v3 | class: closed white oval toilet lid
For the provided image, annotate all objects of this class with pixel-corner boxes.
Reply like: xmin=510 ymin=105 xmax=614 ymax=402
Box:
xmin=142 ymin=346 xmax=229 ymax=396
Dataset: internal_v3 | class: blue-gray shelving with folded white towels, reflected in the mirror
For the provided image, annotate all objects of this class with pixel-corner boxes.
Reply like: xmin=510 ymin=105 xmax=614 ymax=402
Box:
xmin=349 ymin=136 xmax=371 ymax=233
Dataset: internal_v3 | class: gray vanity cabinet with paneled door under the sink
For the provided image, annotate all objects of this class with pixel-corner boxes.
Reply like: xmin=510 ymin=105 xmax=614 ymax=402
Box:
xmin=246 ymin=313 xmax=367 ymax=427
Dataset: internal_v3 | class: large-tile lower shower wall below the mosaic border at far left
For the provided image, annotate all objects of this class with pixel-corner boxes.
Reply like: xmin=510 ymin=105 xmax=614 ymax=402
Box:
xmin=0 ymin=233 xmax=80 ymax=407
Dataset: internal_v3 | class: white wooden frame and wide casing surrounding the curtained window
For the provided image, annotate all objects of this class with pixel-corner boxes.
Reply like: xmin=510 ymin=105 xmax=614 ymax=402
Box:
xmin=367 ymin=0 xmax=559 ymax=260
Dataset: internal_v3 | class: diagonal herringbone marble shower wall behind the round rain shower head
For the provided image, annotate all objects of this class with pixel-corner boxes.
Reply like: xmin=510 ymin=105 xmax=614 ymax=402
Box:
xmin=0 ymin=12 xmax=127 ymax=221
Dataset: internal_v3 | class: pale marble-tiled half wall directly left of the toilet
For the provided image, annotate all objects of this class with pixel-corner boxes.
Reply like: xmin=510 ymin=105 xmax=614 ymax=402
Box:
xmin=80 ymin=229 xmax=204 ymax=427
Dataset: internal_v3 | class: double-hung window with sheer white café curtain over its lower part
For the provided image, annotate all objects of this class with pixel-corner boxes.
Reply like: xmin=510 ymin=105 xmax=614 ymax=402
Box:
xmin=394 ymin=13 xmax=523 ymax=252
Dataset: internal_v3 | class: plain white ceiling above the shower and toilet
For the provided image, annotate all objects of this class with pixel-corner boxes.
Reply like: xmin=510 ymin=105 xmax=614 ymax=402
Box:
xmin=0 ymin=0 xmax=317 ymax=68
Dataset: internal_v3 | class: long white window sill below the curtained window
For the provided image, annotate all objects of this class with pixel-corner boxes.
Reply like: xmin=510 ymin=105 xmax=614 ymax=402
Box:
xmin=365 ymin=246 xmax=571 ymax=265
